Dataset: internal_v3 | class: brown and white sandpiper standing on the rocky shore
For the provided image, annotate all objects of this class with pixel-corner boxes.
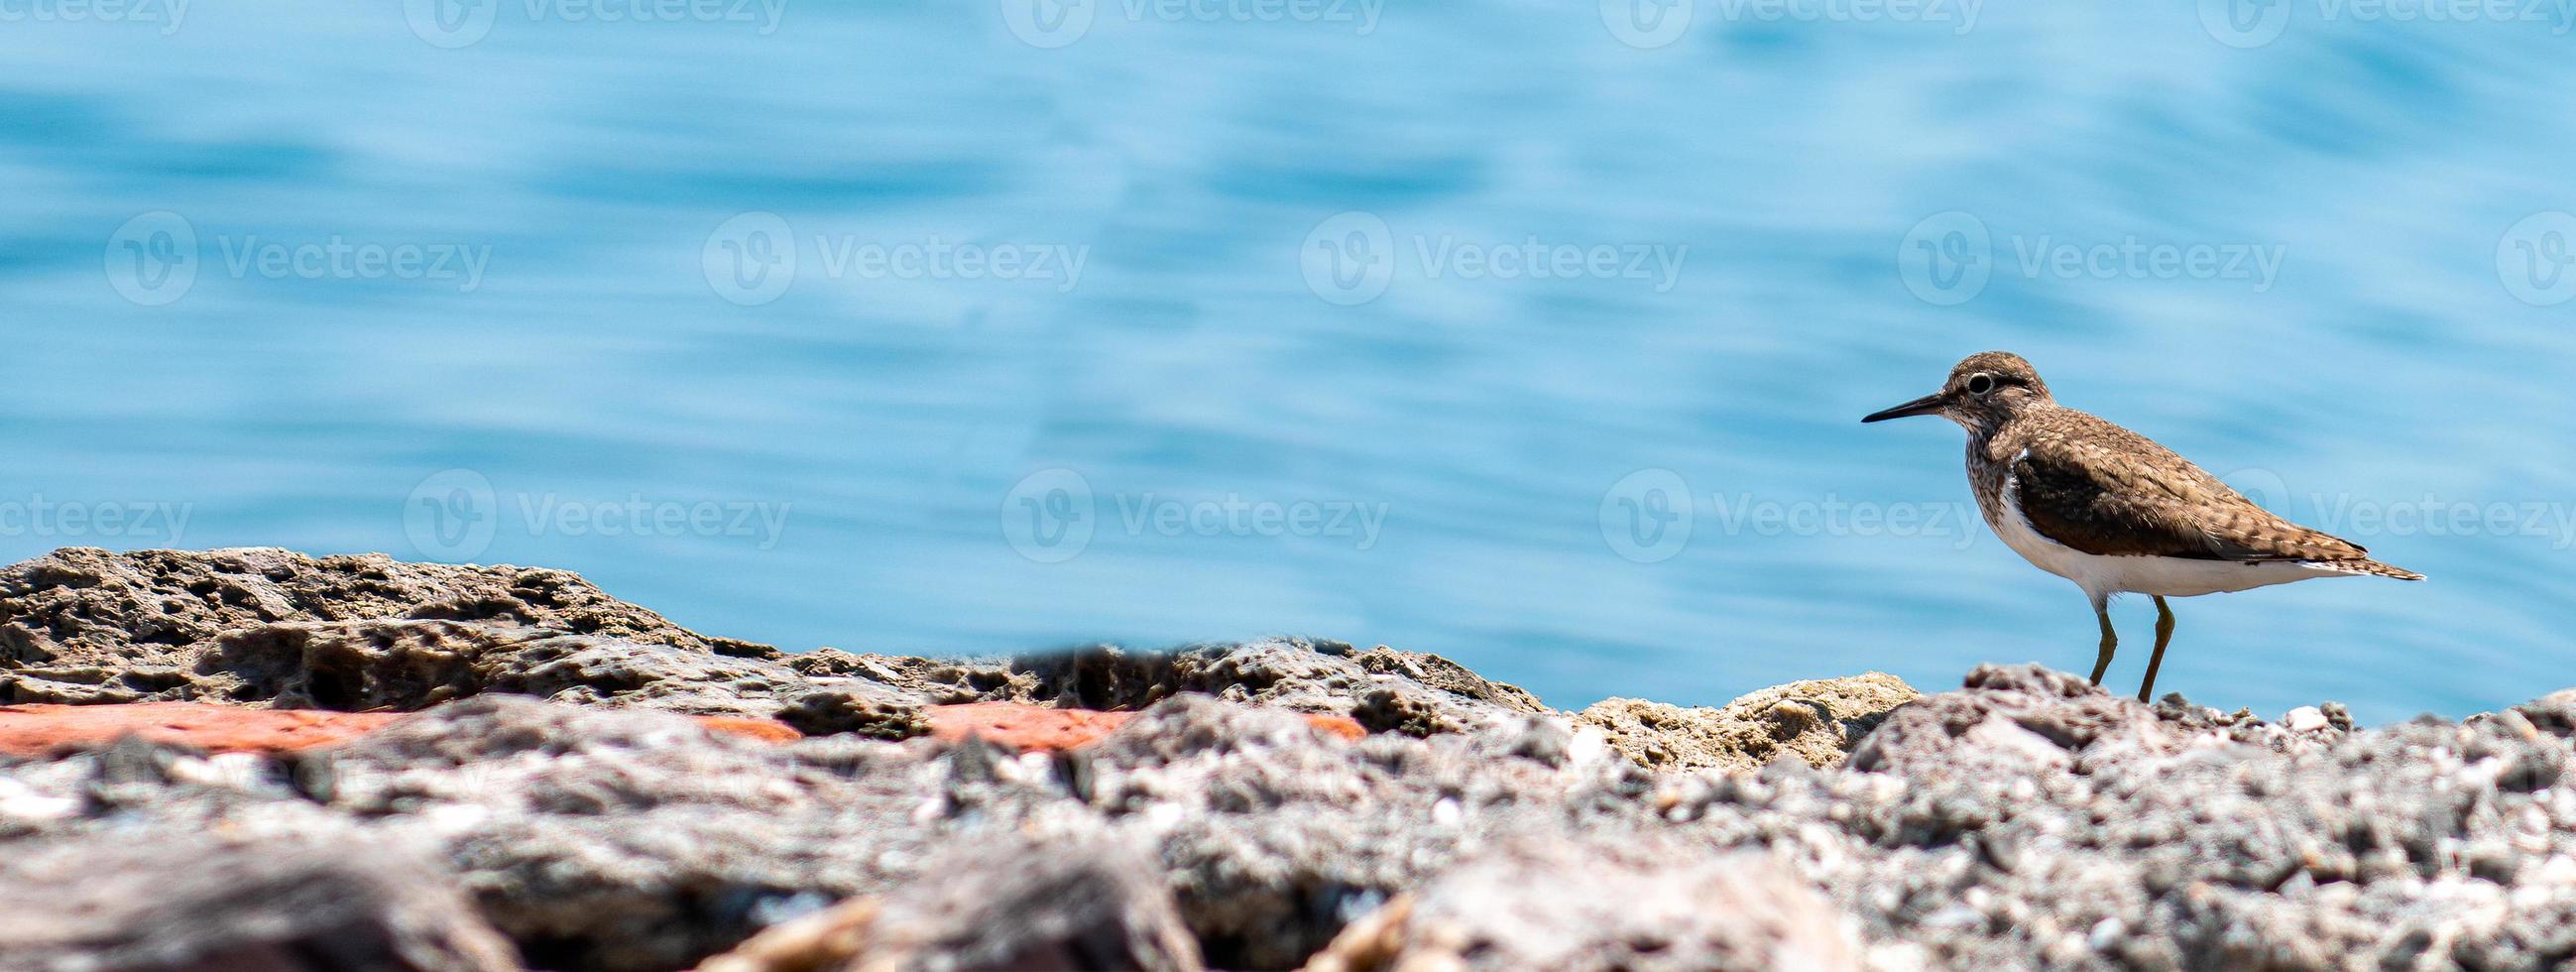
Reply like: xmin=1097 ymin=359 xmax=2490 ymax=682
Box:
xmin=1862 ymin=351 xmax=2424 ymax=701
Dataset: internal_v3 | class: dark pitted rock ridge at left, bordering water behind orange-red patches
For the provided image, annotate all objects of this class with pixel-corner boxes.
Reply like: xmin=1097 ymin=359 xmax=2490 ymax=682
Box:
xmin=0 ymin=549 xmax=1546 ymax=737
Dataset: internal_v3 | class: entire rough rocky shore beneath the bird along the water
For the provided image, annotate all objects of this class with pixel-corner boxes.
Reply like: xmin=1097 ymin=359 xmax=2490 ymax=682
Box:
xmin=0 ymin=549 xmax=2576 ymax=972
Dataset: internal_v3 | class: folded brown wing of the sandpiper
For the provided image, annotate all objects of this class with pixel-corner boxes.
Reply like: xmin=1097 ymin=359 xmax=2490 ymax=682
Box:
xmin=2012 ymin=416 xmax=2368 ymax=562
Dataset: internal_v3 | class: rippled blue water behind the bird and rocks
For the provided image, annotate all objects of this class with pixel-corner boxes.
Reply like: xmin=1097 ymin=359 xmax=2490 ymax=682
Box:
xmin=0 ymin=0 xmax=2576 ymax=722
